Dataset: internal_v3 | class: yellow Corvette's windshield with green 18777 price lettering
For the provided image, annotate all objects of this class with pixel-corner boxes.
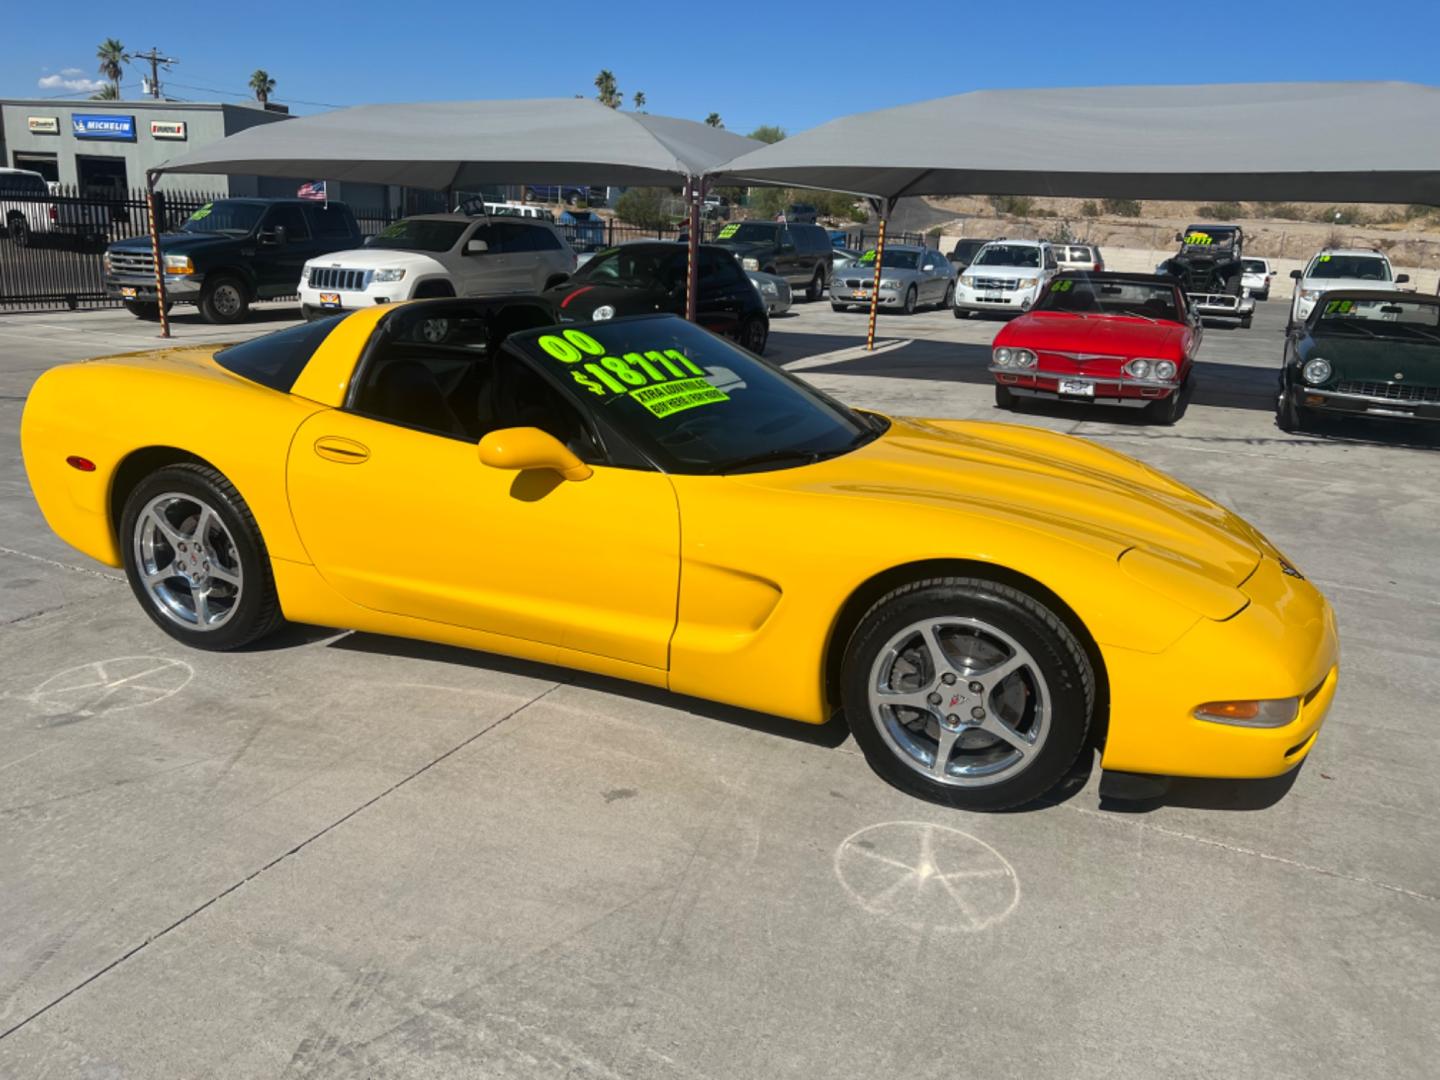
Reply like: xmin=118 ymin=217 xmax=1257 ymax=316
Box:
xmin=508 ymin=315 xmax=884 ymax=474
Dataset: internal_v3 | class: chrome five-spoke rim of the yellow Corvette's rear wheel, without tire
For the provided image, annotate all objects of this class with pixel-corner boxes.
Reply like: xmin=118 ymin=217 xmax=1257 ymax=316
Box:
xmin=134 ymin=491 xmax=243 ymax=631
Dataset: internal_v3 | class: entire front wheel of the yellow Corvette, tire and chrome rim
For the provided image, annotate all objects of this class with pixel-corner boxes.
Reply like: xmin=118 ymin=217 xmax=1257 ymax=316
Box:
xmin=841 ymin=577 xmax=1096 ymax=811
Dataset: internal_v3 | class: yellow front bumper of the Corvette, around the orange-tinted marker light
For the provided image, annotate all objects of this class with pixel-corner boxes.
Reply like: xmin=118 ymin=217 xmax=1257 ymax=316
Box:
xmin=1100 ymin=553 xmax=1339 ymax=779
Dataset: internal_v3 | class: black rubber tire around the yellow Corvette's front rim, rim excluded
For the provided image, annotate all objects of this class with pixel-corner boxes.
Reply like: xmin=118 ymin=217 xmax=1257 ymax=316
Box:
xmin=841 ymin=577 xmax=1094 ymax=811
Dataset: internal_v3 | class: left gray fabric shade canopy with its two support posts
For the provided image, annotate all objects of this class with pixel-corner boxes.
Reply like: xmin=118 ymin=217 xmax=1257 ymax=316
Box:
xmin=147 ymin=98 xmax=760 ymax=337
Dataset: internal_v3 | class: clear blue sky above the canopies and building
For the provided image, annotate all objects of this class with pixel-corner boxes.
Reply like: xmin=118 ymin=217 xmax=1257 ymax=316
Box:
xmin=0 ymin=0 xmax=1440 ymax=132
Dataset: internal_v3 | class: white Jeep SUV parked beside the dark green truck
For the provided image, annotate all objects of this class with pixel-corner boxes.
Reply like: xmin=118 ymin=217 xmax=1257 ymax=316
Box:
xmin=300 ymin=213 xmax=575 ymax=318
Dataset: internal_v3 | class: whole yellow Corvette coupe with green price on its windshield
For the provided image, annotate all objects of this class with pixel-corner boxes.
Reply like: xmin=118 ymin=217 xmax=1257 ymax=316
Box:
xmin=22 ymin=298 xmax=1338 ymax=809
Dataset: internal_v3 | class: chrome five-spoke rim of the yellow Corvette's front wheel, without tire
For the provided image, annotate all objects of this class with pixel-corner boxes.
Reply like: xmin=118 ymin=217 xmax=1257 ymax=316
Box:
xmin=870 ymin=616 xmax=1050 ymax=788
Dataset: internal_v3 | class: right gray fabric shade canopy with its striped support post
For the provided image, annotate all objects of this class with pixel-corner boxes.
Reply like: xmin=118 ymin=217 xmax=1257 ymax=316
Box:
xmin=711 ymin=82 xmax=1440 ymax=346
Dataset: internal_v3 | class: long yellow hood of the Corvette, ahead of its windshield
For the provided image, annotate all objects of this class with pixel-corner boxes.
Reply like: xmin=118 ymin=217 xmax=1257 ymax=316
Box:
xmin=734 ymin=419 xmax=1266 ymax=586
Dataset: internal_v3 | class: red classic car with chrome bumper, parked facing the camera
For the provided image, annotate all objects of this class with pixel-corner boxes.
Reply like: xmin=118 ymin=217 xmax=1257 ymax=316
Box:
xmin=989 ymin=272 xmax=1201 ymax=423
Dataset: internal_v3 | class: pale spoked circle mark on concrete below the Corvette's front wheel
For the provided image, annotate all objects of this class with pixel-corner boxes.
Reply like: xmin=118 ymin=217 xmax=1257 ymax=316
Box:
xmin=835 ymin=821 xmax=1020 ymax=933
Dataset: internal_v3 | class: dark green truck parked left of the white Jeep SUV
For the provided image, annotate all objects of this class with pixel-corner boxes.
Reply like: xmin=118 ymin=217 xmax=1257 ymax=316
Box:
xmin=105 ymin=199 xmax=364 ymax=323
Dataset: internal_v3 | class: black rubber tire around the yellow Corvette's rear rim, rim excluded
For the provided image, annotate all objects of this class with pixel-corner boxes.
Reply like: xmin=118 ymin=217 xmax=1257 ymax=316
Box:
xmin=120 ymin=465 xmax=278 ymax=651
